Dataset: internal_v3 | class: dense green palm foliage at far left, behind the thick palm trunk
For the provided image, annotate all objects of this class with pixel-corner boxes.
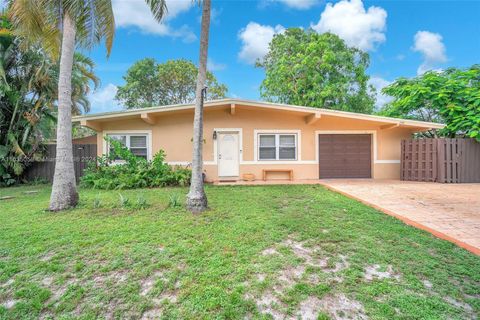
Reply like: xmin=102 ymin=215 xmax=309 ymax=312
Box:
xmin=0 ymin=15 xmax=98 ymax=185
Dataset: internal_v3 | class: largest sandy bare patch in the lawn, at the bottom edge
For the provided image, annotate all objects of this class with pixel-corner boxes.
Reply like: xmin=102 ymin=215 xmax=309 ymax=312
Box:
xmin=245 ymin=236 xmax=360 ymax=320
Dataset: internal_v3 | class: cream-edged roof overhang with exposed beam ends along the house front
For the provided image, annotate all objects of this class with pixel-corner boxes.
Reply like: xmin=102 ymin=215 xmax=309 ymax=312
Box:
xmin=72 ymin=99 xmax=445 ymax=131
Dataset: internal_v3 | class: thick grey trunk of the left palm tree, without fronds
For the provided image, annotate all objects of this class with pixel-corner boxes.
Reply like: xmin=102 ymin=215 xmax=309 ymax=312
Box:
xmin=49 ymin=13 xmax=78 ymax=211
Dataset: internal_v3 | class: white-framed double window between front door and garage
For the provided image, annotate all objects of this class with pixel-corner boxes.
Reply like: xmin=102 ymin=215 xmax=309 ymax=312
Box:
xmin=258 ymin=133 xmax=297 ymax=160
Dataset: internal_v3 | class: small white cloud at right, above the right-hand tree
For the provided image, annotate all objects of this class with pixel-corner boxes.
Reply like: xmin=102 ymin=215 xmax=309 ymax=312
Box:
xmin=412 ymin=31 xmax=447 ymax=74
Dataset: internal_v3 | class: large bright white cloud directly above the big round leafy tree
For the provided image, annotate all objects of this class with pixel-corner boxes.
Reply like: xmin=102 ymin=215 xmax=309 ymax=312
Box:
xmin=311 ymin=0 xmax=387 ymax=51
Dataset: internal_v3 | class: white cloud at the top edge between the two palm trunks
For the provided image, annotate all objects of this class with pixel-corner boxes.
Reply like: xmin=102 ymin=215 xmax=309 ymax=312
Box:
xmin=113 ymin=0 xmax=196 ymax=42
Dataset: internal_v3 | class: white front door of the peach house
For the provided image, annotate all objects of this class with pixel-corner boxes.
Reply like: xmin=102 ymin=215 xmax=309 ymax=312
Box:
xmin=217 ymin=132 xmax=239 ymax=177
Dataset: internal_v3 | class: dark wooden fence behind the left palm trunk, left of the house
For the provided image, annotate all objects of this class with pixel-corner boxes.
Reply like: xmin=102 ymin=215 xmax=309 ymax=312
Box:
xmin=23 ymin=144 xmax=97 ymax=183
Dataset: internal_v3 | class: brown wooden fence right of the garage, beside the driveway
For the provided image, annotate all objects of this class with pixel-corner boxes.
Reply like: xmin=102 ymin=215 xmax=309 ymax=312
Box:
xmin=400 ymin=138 xmax=480 ymax=183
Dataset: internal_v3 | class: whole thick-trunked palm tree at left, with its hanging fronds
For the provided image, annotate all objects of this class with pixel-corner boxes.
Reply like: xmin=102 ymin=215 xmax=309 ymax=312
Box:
xmin=9 ymin=0 xmax=166 ymax=211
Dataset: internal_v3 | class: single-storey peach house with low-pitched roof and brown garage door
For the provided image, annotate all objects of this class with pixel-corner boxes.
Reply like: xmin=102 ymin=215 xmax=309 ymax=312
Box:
xmin=74 ymin=99 xmax=443 ymax=181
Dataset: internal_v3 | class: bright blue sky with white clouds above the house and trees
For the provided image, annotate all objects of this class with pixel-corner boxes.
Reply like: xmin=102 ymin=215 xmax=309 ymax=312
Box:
xmin=86 ymin=0 xmax=480 ymax=113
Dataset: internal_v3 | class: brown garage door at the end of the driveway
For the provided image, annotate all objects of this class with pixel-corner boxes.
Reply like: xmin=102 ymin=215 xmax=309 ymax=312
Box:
xmin=318 ymin=134 xmax=372 ymax=179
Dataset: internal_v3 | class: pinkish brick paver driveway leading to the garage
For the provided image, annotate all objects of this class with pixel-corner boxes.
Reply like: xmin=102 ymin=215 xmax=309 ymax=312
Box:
xmin=321 ymin=179 xmax=480 ymax=255
